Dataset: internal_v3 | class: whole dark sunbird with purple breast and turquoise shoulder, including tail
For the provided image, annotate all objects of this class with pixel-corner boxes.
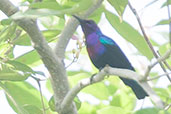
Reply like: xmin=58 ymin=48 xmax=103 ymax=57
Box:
xmin=73 ymin=15 xmax=148 ymax=99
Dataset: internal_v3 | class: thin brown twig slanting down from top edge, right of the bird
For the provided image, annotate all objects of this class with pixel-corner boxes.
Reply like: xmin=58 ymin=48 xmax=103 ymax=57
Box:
xmin=128 ymin=0 xmax=171 ymax=82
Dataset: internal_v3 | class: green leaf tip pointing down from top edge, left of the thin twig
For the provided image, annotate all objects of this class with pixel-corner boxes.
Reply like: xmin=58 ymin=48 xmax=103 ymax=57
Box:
xmin=108 ymin=0 xmax=128 ymax=17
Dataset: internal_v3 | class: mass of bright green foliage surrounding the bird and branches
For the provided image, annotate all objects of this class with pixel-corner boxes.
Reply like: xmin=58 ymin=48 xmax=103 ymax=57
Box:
xmin=0 ymin=0 xmax=171 ymax=114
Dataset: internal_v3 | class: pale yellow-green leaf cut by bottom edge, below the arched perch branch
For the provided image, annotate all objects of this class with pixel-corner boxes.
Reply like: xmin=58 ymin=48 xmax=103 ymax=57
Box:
xmin=97 ymin=106 xmax=126 ymax=114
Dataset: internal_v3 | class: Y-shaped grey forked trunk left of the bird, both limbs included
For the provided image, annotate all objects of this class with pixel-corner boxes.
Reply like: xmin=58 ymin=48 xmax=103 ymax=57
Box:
xmin=0 ymin=0 xmax=103 ymax=114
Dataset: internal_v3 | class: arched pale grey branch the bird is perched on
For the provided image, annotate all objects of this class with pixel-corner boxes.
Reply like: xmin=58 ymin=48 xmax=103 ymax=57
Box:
xmin=61 ymin=66 xmax=164 ymax=110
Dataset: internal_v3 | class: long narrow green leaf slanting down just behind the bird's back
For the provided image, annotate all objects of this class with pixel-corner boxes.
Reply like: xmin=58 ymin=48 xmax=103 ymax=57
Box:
xmin=105 ymin=10 xmax=153 ymax=60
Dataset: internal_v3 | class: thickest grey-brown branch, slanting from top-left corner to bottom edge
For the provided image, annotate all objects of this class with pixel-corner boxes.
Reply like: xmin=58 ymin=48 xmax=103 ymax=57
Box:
xmin=0 ymin=0 xmax=77 ymax=114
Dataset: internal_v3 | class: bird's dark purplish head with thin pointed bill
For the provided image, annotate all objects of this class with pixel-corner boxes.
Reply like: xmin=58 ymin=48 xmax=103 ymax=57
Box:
xmin=73 ymin=15 xmax=100 ymax=36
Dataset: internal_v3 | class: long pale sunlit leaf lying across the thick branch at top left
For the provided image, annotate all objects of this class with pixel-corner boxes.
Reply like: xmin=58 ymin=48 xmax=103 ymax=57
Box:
xmin=11 ymin=0 xmax=93 ymax=20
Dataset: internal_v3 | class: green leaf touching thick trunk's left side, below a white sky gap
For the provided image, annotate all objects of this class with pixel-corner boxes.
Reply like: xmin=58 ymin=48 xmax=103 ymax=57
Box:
xmin=15 ymin=50 xmax=41 ymax=66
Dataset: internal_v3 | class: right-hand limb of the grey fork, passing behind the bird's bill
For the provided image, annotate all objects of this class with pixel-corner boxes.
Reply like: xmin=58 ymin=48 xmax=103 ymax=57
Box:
xmin=55 ymin=0 xmax=103 ymax=60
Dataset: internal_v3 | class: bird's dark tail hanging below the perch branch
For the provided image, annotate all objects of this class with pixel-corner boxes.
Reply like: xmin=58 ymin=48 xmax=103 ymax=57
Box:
xmin=121 ymin=78 xmax=148 ymax=99
